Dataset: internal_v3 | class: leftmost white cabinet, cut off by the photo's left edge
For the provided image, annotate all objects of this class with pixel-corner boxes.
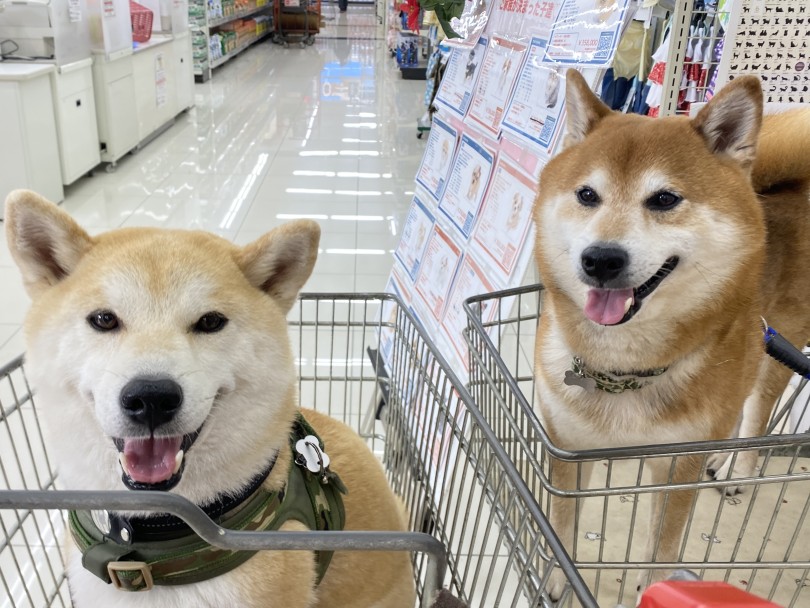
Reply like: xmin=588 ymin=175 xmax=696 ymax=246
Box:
xmin=0 ymin=63 xmax=64 ymax=218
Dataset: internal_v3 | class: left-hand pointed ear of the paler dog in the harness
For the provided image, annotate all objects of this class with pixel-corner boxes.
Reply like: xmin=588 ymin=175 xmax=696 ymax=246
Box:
xmin=5 ymin=190 xmax=93 ymax=298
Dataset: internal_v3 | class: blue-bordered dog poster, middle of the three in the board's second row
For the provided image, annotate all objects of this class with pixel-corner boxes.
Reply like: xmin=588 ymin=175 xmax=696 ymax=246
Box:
xmin=439 ymin=135 xmax=494 ymax=239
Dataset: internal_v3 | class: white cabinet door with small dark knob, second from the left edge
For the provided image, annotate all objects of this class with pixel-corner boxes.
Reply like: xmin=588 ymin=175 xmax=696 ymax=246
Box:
xmin=51 ymin=58 xmax=101 ymax=184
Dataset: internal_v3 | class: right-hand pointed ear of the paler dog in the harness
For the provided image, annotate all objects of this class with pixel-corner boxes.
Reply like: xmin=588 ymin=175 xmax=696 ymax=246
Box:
xmin=237 ymin=220 xmax=321 ymax=313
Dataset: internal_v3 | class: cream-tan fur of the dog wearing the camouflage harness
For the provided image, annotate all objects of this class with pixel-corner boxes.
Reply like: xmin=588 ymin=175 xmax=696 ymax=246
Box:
xmin=6 ymin=191 xmax=415 ymax=608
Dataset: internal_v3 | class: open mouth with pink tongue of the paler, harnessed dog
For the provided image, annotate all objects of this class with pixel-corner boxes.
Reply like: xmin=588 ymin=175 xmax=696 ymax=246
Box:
xmin=113 ymin=427 xmax=202 ymax=491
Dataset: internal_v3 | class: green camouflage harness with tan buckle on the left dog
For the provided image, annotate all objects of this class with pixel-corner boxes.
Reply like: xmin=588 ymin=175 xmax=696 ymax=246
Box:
xmin=69 ymin=414 xmax=346 ymax=591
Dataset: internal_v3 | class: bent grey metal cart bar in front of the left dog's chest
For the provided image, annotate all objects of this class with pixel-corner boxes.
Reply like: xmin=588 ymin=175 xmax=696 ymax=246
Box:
xmin=0 ymin=490 xmax=447 ymax=608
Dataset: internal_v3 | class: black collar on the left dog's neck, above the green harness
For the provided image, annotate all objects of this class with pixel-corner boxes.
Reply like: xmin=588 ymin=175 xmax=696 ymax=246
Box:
xmin=98 ymin=452 xmax=278 ymax=545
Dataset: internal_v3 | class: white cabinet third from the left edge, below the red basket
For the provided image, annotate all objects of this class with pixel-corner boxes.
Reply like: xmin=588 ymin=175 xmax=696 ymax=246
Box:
xmin=93 ymin=51 xmax=140 ymax=166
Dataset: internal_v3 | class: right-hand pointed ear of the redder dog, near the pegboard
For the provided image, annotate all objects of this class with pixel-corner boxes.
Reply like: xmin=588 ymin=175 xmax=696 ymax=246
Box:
xmin=692 ymin=76 xmax=762 ymax=169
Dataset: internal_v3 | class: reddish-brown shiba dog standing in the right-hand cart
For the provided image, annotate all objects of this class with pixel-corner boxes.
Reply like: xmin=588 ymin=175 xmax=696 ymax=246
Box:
xmin=534 ymin=70 xmax=810 ymax=595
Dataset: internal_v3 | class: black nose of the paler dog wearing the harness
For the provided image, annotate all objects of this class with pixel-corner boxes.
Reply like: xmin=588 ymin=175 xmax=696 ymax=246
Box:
xmin=121 ymin=378 xmax=183 ymax=431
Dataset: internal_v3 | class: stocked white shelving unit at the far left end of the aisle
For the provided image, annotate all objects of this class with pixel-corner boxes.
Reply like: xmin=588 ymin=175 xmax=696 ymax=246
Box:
xmin=188 ymin=0 xmax=273 ymax=82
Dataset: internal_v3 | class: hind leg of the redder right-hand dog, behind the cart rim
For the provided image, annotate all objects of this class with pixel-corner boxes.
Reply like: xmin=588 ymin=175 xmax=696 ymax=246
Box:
xmin=710 ymin=357 xmax=791 ymax=495
